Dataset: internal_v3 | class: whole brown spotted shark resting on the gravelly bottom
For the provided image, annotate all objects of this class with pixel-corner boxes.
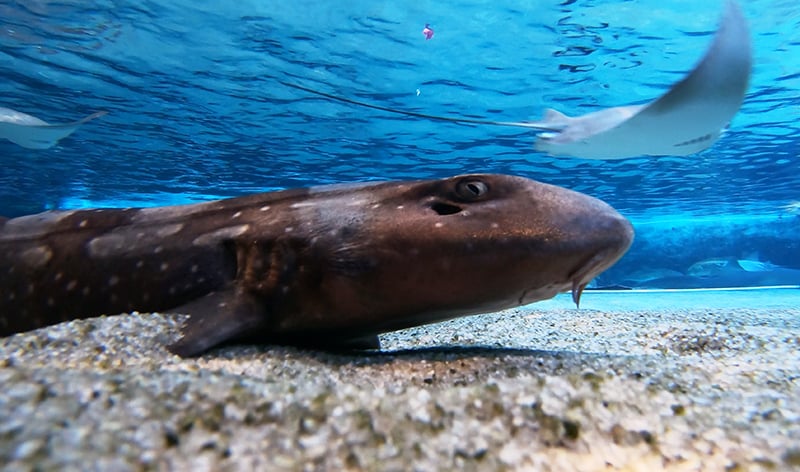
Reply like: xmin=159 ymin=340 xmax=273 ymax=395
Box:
xmin=0 ymin=174 xmax=633 ymax=356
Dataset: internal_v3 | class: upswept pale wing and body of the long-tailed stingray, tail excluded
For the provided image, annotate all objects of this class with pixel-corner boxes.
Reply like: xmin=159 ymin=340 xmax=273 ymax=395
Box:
xmin=536 ymin=0 xmax=752 ymax=159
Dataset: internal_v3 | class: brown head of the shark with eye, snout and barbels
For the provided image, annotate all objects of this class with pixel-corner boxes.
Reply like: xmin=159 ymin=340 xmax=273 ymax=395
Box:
xmin=304 ymin=175 xmax=633 ymax=329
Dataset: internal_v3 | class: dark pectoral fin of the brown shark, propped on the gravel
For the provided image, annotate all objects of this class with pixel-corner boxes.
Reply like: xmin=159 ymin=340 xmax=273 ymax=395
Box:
xmin=167 ymin=288 xmax=267 ymax=357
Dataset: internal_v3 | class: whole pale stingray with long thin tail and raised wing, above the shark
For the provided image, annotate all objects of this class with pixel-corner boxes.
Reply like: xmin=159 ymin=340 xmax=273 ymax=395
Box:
xmin=281 ymin=0 xmax=752 ymax=159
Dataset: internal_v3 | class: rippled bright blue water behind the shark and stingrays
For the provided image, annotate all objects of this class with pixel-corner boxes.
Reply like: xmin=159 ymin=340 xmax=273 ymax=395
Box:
xmin=0 ymin=0 xmax=800 ymax=283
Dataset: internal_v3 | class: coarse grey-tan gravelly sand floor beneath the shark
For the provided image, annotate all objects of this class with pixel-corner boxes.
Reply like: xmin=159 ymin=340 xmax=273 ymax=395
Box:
xmin=0 ymin=289 xmax=800 ymax=471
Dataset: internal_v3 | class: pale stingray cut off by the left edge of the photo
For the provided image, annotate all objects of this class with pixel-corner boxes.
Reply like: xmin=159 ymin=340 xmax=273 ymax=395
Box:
xmin=0 ymin=107 xmax=107 ymax=149
